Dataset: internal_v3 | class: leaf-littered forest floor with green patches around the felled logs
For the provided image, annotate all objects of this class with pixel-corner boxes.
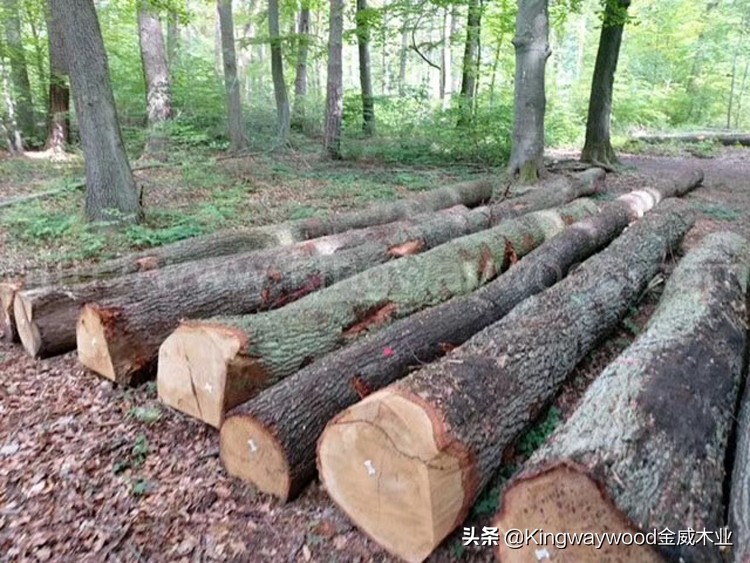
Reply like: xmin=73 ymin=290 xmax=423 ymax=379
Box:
xmin=0 ymin=149 xmax=750 ymax=563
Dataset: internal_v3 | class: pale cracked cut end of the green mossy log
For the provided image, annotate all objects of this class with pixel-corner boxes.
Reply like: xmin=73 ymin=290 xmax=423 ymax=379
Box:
xmin=157 ymin=323 xmax=267 ymax=428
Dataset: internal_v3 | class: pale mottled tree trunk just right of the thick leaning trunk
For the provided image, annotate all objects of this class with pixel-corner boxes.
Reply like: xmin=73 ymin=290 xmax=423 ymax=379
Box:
xmin=138 ymin=0 xmax=172 ymax=159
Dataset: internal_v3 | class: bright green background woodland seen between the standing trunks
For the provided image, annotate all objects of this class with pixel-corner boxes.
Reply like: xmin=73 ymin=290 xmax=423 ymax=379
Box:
xmin=0 ymin=0 xmax=750 ymax=165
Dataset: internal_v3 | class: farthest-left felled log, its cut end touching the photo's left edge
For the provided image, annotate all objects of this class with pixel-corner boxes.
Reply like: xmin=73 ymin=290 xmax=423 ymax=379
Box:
xmin=0 ymin=179 xmax=500 ymax=342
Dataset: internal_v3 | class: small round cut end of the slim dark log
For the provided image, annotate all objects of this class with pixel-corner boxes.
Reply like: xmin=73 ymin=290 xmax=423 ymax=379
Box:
xmin=219 ymin=415 xmax=291 ymax=502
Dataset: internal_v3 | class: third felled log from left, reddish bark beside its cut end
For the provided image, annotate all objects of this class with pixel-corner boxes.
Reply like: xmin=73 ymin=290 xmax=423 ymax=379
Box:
xmin=76 ymin=169 xmax=604 ymax=384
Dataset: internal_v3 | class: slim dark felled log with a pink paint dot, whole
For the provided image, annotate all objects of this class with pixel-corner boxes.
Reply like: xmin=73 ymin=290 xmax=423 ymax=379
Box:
xmin=220 ymin=170 xmax=699 ymax=502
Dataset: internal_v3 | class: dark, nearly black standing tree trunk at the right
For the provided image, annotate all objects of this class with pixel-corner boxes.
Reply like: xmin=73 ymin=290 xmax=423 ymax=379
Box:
xmin=581 ymin=0 xmax=630 ymax=167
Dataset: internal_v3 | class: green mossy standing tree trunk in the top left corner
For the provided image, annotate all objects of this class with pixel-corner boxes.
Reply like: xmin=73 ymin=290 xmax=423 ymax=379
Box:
xmin=3 ymin=0 xmax=36 ymax=138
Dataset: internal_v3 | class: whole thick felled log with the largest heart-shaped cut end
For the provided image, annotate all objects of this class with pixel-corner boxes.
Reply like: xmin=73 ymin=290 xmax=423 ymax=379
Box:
xmin=318 ymin=204 xmax=692 ymax=561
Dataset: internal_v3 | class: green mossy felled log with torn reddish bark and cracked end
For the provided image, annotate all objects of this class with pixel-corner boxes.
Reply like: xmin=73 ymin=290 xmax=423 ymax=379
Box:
xmin=157 ymin=200 xmax=597 ymax=428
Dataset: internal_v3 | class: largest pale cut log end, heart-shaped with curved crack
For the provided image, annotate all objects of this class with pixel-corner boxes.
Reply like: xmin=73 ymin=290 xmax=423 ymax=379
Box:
xmin=318 ymin=390 xmax=467 ymax=561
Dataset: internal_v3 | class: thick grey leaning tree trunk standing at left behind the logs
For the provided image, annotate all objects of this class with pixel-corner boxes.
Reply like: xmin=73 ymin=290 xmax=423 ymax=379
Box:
xmin=51 ymin=0 xmax=142 ymax=223
